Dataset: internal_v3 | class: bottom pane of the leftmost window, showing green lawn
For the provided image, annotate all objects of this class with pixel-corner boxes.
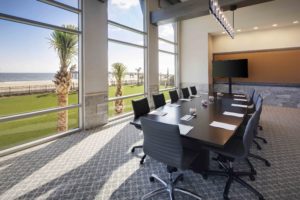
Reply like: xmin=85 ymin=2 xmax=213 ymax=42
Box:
xmin=0 ymin=108 xmax=78 ymax=150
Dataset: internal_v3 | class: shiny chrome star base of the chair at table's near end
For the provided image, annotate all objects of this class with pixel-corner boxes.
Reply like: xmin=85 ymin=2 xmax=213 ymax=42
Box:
xmin=142 ymin=173 xmax=202 ymax=200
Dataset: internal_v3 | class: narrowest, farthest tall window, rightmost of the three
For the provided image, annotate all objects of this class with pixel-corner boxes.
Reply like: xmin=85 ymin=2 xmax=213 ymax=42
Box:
xmin=158 ymin=23 xmax=178 ymax=99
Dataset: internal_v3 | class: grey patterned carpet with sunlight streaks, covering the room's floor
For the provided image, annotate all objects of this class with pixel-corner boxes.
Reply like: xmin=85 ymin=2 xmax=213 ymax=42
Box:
xmin=0 ymin=106 xmax=300 ymax=200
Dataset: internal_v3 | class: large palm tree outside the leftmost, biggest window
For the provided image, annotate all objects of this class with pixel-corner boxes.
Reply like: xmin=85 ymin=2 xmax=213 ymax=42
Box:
xmin=50 ymin=25 xmax=78 ymax=132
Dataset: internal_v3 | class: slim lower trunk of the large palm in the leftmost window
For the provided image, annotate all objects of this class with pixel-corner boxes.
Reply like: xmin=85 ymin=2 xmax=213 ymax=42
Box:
xmin=57 ymin=93 xmax=68 ymax=132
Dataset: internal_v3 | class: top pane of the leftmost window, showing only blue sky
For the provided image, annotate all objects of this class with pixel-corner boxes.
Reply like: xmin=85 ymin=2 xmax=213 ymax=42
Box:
xmin=0 ymin=0 xmax=78 ymax=28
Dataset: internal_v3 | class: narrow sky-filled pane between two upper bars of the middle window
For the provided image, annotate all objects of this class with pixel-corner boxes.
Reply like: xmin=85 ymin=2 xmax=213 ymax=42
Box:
xmin=108 ymin=25 xmax=144 ymax=46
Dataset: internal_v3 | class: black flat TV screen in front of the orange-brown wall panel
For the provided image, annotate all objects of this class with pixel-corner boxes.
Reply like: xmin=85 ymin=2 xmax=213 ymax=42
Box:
xmin=213 ymin=59 xmax=248 ymax=78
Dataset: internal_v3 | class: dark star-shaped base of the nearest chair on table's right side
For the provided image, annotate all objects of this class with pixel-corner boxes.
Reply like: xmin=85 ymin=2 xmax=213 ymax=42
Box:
xmin=202 ymin=162 xmax=264 ymax=200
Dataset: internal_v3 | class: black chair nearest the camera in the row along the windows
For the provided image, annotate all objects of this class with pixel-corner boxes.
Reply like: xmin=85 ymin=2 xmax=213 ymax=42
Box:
xmin=131 ymin=98 xmax=150 ymax=164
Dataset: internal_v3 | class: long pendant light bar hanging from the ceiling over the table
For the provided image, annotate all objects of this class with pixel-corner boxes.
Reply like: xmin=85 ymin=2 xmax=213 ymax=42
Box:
xmin=209 ymin=0 xmax=234 ymax=39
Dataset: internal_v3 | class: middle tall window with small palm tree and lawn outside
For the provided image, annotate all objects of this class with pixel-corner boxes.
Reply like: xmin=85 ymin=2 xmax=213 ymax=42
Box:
xmin=108 ymin=0 xmax=146 ymax=117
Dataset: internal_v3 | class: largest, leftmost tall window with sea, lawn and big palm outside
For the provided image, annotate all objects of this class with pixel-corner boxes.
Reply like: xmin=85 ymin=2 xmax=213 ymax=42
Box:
xmin=0 ymin=0 xmax=81 ymax=150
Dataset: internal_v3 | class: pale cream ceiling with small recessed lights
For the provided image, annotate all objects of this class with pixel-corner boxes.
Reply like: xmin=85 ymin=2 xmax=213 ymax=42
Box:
xmin=177 ymin=0 xmax=300 ymax=34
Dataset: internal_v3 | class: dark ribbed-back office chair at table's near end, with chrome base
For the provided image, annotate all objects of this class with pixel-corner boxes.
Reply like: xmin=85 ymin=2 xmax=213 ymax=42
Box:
xmin=141 ymin=117 xmax=201 ymax=200
